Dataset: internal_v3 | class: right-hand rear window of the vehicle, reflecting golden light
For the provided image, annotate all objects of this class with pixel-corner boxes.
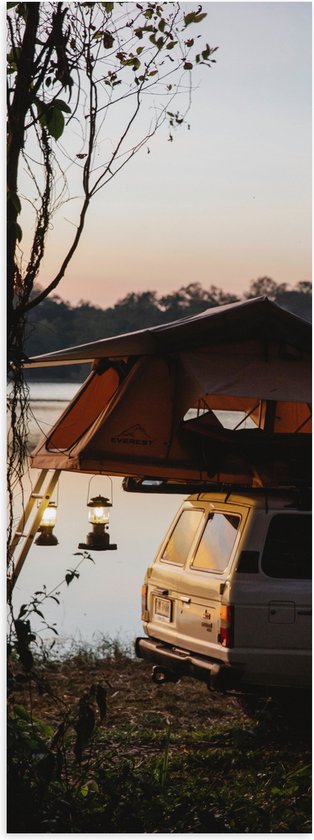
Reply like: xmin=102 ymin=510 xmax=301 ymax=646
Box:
xmin=192 ymin=513 xmax=240 ymax=572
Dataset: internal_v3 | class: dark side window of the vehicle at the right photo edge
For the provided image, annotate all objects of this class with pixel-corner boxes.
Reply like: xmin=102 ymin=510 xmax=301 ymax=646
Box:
xmin=262 ymin=513 xmax=312 ymax=580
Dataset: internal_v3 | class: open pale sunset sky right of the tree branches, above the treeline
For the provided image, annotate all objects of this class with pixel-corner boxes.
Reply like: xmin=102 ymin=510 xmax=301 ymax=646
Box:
xmin=22 ymin=2 xmax=312 ymax=308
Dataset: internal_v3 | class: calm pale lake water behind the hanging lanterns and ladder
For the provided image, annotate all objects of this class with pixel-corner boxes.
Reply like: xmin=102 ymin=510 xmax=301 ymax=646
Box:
xmin=13 ymin=383 xmax=184 ymax=645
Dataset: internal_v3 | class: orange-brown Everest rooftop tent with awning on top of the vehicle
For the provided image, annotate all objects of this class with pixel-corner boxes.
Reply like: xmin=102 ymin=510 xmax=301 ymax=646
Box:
xmin=28 ymin=298 xmax=311 ymax=486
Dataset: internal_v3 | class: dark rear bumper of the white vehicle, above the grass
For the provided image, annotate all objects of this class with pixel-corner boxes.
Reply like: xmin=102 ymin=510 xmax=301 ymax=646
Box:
xmin=135 ymin=637 xmax=242 ymax=691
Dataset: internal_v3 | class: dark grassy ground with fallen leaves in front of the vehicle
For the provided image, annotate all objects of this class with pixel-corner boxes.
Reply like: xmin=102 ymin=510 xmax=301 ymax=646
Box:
xmin=8 ymin=645 xmax=311 ymax=833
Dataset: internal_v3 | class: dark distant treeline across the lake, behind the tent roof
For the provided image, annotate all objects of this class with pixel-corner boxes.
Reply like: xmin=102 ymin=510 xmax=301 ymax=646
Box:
xmin=26 ymin=277 xmax=312 ymax=381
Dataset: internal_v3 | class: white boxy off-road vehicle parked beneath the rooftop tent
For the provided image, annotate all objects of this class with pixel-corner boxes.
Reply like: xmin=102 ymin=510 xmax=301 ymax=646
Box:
xmin=135 ymin=490 xmax=311 ymax=693
